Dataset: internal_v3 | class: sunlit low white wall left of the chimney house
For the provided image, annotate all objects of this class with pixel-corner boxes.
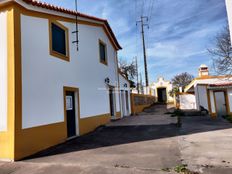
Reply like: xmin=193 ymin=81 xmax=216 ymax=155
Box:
xmin=180 ymin=94 xmax=196 ymax=109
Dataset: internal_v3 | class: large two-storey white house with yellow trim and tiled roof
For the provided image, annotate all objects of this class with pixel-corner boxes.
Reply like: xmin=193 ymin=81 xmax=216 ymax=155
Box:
xmin=0 ymin=0 xmax=130 ymax=160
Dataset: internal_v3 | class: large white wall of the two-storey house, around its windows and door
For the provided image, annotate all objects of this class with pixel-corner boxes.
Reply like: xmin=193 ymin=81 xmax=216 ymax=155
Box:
xmin=21 ymin=15 xmax=120 ymax=128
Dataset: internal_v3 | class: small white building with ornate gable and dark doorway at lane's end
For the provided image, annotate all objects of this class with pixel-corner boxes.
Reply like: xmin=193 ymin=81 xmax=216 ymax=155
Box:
xmin=150 ymin=77 xmax=174 ymax=103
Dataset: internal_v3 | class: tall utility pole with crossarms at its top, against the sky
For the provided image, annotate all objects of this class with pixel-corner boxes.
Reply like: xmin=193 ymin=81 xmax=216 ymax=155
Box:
xmin=136 ymin=16 xmax=149 ymax=87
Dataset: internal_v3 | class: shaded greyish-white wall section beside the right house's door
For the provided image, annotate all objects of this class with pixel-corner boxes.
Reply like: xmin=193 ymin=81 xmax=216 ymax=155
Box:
xmin=195 ymin=85 xmax=209 ymax=110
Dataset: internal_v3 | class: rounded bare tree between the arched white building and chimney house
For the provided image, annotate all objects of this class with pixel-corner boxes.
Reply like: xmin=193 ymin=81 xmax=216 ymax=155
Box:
xmin=169 ymin=72 xmax=194 ymax=96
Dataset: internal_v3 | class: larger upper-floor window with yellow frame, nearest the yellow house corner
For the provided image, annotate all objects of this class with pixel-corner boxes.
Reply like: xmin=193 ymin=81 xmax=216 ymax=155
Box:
xmin=50 ymin=21 xmax=69 ymax=61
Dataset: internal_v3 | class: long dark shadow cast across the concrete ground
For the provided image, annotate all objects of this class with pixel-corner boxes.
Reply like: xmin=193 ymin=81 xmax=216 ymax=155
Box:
xmin=25 ymin=105 xmax=232 ymax=161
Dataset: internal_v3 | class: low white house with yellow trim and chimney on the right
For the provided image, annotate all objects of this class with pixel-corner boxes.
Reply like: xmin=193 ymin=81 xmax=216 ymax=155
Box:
xmin=180 ymin=65 xmax=232 ymax=117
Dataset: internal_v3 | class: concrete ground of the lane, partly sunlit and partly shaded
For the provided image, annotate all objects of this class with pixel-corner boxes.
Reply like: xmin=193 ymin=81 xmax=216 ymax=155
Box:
xmin=0 ymin=105 xmax=232 ymax=174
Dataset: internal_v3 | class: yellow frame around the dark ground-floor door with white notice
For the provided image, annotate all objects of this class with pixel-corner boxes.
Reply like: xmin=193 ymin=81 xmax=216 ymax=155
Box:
xmin=63 ymin=86 xmax=80 ymax=139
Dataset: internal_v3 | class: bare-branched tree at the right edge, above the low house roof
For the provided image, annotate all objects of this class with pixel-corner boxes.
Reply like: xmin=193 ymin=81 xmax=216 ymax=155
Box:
xmin=208 ymin=26 xmax=232 ymax=75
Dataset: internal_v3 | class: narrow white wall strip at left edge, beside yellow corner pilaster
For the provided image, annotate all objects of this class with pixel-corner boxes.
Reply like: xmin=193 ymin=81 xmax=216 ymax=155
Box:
xmin=0 ymin=12 xmax=7 ymax=131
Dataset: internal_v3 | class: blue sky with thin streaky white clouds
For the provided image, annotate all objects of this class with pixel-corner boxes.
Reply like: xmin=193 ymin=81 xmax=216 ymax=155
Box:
xmin=43 ymin=0 xmax=227 ymax=82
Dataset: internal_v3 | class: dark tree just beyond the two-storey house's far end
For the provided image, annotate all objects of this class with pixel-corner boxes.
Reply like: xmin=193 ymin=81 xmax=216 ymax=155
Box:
xmin=119 ymin=60 xmax=137 ymax=88
